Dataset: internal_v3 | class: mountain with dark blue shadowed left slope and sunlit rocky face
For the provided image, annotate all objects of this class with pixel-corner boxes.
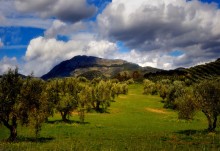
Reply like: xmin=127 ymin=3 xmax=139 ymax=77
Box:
xmin=41 ymin=56 xmax=160 ymax=80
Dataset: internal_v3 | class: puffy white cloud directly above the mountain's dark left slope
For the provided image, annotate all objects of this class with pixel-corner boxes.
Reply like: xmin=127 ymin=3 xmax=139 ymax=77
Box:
xmin=24 ymin=34 xmax=117 ymax=76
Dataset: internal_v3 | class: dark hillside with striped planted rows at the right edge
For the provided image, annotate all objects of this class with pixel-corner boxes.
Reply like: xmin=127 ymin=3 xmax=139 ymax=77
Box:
xmin=144 ymin=59 xmax=220 ymax=82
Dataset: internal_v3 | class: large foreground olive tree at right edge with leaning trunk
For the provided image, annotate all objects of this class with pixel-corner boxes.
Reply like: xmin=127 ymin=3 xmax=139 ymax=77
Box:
xmin=178 ymin=80 xmax=220 ymax=131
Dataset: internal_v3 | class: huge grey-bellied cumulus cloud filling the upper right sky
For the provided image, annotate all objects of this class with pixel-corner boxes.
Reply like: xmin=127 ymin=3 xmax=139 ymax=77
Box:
xmin=97 ymin=0 xmax=220 ymax=67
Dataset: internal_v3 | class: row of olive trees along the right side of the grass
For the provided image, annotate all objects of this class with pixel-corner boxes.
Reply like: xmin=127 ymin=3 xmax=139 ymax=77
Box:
xmin=144 ymin=78 xmax=220 ymax=131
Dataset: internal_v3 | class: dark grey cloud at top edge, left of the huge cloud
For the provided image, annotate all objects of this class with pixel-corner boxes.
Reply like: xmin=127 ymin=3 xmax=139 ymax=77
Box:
xmin=15 ymin=0 xmax=97 ymax=22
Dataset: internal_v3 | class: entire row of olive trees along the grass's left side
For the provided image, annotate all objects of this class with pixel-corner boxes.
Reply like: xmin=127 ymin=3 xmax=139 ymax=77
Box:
xmin=0 ymin=69 xmax=128 ymax=141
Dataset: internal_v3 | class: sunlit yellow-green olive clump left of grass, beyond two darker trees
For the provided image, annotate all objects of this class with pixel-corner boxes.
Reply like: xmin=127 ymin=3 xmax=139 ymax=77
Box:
xmin=46 ymin=77 xmax=128 ymax=119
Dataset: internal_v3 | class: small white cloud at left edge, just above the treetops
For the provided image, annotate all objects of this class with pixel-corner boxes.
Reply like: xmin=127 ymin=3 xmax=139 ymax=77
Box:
xmin=0 ymin=56 xmax=18 ymax=74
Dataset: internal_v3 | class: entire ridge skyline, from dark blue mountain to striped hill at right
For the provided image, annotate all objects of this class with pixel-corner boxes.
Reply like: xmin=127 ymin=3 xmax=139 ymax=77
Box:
xmin=41 ymin=55 xmax=220 ymax=81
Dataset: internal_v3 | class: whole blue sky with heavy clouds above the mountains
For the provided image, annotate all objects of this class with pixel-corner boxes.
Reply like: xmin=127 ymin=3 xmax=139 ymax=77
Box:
xmin=0 ymin=0 xmax=220 ymax=76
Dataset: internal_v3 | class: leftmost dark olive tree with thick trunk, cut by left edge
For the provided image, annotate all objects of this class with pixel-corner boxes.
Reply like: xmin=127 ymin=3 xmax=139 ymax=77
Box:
xmin=0 ymin=69 xmax=23 ymax=141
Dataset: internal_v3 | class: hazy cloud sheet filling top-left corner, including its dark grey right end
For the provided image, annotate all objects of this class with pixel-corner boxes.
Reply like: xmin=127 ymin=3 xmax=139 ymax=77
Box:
xmin=0 ymin=0 xmax=96 ymax=29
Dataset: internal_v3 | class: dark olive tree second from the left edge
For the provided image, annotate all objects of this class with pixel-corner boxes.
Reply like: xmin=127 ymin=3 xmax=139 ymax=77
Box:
xmin=19 ymin=77 xmax=50 ymax=137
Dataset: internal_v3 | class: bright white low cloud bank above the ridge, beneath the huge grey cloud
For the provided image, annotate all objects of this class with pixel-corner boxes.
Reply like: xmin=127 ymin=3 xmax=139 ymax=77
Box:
xmin=109 ymin=46 xmax=216 ymax=70
